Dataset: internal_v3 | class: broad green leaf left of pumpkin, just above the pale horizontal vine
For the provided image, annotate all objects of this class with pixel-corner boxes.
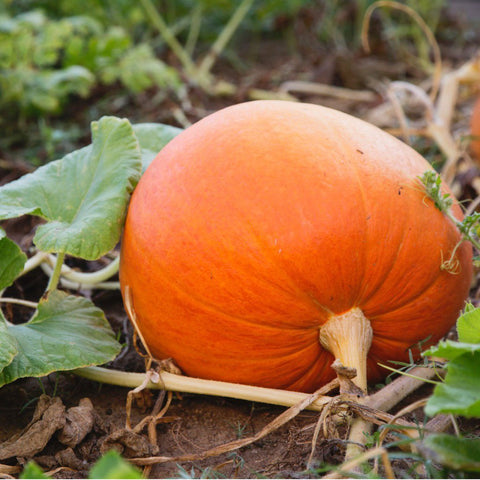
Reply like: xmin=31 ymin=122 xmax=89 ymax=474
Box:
xmin=0 ymin=290 xmax=121 ymax=387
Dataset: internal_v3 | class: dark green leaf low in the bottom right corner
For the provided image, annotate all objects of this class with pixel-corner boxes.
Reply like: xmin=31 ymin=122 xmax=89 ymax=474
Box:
xmin=421 ymin=433 xmax=480 ymax=472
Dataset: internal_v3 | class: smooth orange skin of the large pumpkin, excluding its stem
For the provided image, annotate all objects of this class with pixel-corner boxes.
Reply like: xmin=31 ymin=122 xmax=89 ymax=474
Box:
xmin=120 ymin=101 xmax=472 ymax=392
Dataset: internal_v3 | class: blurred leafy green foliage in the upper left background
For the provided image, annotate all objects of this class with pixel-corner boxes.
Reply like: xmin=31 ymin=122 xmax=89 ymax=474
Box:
xmin=0 ymin=10 xmax=180 ymax=119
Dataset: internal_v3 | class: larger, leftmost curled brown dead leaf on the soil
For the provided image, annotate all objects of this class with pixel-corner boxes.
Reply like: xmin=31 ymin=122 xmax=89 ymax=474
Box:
xmin=0 ymin=395 xmax=65 ymax=460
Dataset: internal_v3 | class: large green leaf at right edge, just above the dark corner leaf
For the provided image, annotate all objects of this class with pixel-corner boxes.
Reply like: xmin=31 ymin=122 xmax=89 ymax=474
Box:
xmin=425 ymin=351 xmax=480 ymax=417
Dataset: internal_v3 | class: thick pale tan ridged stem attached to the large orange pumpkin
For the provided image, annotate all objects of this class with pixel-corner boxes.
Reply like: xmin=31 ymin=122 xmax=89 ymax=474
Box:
xmin=320 ymin=307 xmax=373 ymax=393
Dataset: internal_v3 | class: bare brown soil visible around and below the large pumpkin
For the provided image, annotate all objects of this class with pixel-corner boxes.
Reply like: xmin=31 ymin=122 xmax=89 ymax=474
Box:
xmin=0 ymin=1 xmax=480 ymax=478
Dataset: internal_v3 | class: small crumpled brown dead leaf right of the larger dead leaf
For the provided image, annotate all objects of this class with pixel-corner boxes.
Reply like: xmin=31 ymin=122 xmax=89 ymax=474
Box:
xmin=58 ymin=398 xmax=95 ymax=448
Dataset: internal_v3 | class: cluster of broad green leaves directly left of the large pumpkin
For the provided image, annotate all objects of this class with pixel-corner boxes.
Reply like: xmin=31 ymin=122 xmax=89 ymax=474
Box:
xmin=0 ymin=117 xmax=181 ymax=390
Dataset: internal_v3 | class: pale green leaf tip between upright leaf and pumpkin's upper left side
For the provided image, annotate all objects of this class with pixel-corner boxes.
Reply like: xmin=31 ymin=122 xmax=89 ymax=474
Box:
xmin=133 ymin=123 xmax=183 ymax=171
